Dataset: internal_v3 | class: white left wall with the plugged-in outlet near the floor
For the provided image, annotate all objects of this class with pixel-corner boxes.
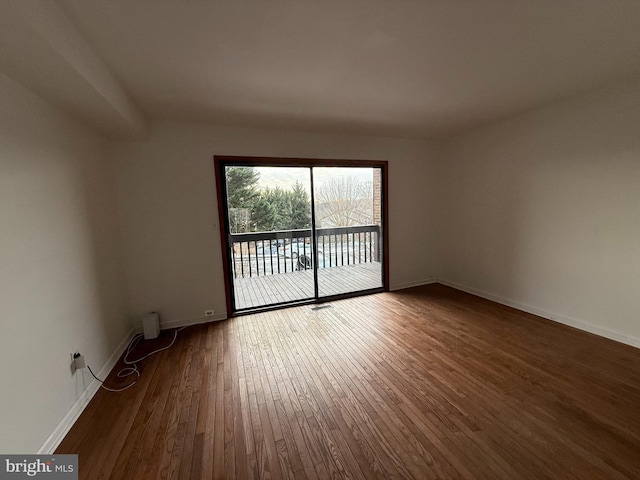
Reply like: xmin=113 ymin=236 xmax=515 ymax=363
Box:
xmin=0 ymin=75 xmax=130 ymax=453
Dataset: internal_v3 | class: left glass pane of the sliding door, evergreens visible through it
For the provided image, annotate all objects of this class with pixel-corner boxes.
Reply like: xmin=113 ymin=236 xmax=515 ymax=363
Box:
xmin=224 ymin=166 xmax=315 ymax=311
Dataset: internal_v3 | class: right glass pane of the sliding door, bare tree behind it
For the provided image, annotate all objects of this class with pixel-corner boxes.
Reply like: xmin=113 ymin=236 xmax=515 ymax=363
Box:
xmin=313 ymin=167 xmax=383 ymax=297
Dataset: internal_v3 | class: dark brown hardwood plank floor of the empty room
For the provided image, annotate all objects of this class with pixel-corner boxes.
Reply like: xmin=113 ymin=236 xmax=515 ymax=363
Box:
xmin=57 ymin=285 xmax=640 ymax=480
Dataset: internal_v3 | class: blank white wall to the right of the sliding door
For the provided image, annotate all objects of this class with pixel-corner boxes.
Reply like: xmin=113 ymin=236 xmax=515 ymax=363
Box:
xmin=439 ymin=81 xmax=640 ymax=346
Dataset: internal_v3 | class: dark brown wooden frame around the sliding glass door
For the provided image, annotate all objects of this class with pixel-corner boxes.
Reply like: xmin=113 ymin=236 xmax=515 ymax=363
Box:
xmin=213 ymin=155 xmax=389 ymax=318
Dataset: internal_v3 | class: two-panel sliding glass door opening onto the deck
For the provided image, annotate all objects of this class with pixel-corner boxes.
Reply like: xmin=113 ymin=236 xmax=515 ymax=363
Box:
xmin=216 ymin=157 xmax=386 ymax=313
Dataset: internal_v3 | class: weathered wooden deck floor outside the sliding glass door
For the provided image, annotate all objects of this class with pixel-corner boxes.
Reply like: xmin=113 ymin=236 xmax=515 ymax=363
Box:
xmin=234 ymin=262 xmax=382 ymax=310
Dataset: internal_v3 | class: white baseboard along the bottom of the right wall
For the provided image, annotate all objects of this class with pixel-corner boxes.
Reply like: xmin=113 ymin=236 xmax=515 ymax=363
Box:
xmin=438 ymin=279 xmax=640 ymax=348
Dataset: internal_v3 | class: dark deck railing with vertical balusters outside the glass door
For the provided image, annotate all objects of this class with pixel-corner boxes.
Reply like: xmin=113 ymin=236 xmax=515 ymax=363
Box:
xmin=229 ymin=225 xmax=380 ymax=278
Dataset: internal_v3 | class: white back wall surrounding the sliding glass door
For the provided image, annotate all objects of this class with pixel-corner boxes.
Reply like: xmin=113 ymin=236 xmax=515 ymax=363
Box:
xmin=112 ymin=123 xmax=437 ymax=326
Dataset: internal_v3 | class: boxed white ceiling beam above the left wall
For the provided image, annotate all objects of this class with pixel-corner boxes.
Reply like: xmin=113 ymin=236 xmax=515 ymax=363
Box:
xmin=0 ymin=0 xmax=147 ymax=139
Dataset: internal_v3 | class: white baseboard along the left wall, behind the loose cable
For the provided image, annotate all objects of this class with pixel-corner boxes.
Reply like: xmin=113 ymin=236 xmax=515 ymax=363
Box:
xmin=37 ymin=329 xmax=135 ymax=455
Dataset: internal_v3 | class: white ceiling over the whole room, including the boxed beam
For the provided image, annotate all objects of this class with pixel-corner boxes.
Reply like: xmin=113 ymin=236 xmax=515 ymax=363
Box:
xmin=0 ymin=0 xmax=640 ymax=137
